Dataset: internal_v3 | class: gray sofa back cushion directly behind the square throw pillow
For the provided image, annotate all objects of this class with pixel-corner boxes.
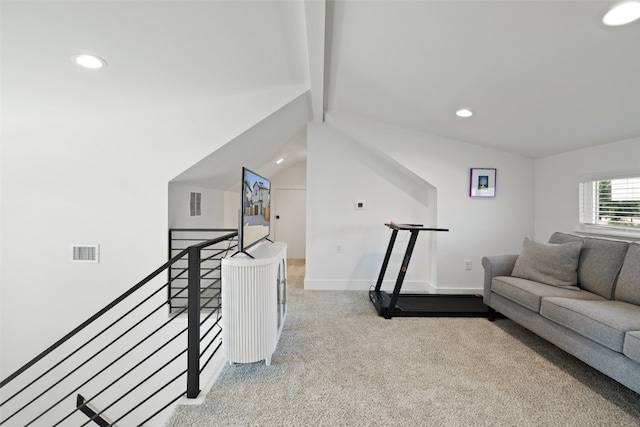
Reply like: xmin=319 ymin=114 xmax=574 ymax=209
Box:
xmin=549 ymin=233 xmax=629 ymax=299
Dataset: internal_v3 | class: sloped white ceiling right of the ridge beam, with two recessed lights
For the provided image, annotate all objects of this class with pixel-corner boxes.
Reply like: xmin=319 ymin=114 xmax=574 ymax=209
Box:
xmin=324 ymin=0 xmax=640 ymax=158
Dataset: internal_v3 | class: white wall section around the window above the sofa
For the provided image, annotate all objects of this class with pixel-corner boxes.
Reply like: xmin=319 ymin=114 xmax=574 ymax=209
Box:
xmin=535 ymin=138 xmax=640 ymax=241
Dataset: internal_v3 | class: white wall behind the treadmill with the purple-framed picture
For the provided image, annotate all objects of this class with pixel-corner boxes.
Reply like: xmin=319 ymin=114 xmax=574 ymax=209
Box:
xmin=305 ymin=114 xmax=534 ymax=292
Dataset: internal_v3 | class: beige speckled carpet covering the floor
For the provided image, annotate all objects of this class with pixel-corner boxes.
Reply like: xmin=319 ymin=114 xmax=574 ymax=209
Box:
xmin=167 ymin=260 xmax=640 ymax=427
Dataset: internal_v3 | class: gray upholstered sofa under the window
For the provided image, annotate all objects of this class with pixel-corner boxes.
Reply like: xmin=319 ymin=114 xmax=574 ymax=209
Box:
xmin=482 ymin=233 xmax=640 ymax=393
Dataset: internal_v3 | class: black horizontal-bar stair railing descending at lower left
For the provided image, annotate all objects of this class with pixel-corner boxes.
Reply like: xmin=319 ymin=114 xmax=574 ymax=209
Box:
xmin=0 ymin=229 xmax=237 ymax=426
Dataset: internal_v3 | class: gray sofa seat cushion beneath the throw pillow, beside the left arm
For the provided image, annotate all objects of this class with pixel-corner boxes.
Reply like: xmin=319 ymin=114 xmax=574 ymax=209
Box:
xmin=491 ymin=276 xmax=606 ymax=313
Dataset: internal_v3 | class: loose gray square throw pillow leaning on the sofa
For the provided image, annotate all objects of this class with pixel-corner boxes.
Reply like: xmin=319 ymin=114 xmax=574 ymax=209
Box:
xmin=511 ymin=238 xmax=582 ymax=287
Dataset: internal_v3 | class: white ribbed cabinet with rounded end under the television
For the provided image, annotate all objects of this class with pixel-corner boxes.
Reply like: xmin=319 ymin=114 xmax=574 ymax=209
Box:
xmin=222 ymin=241 xmax=287 ymax=365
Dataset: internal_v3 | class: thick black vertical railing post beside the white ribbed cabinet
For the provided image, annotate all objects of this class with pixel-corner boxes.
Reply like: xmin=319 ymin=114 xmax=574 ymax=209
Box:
xmin=187 ymin=246 xmax=201 ymax=399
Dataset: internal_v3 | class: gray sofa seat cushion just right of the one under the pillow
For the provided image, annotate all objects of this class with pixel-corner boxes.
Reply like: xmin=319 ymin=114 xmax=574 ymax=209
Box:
xmin=540 ymin=297 xmax=640 ymax=353
